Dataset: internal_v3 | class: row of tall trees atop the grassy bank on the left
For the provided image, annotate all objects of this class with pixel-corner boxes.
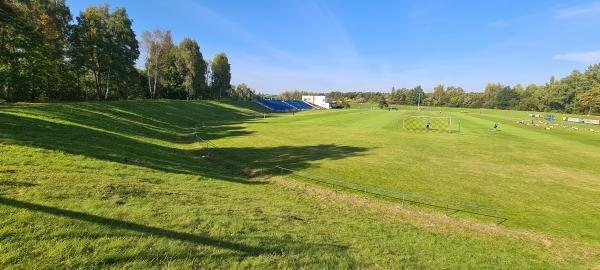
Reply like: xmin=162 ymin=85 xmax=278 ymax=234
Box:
xmin=0 ymin=0 xmax=254 ymax=102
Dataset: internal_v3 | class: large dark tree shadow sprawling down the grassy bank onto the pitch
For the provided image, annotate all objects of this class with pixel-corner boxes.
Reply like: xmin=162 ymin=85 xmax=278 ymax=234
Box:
xmin=0 ymin=102 xmax=367 ymax=184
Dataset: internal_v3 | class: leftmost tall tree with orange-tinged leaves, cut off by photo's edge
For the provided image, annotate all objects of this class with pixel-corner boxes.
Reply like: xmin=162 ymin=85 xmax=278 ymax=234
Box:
xmin=0 ymin=0 xmax=71 ymax=101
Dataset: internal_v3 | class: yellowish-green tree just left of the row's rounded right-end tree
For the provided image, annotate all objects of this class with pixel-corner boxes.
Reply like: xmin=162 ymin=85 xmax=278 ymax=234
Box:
xmin=177 ymin=38 xmax=207 ymax=99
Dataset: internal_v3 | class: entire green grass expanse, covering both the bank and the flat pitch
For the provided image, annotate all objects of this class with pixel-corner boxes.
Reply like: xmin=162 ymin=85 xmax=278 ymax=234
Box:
xmin=0 ymin=101 xmax=600 ymax=269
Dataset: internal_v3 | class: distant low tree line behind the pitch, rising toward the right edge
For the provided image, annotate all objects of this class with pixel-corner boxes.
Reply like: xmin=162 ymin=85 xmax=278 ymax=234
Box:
xmin=278 ymin=64 xmax=600 ymax=114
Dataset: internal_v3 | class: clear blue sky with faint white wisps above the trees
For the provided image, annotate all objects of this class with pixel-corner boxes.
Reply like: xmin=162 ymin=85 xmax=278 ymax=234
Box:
xmin=67 ymin=0 xmax=600 ymax=94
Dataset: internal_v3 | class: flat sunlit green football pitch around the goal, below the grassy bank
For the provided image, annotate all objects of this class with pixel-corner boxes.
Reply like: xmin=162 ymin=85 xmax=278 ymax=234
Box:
xmin=214 ymin=105 xmax=600 ymax=243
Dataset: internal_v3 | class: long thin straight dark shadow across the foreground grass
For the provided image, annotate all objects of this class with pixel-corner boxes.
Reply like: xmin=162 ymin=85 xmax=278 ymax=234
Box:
xmin=0 ymin=197 xmax=347 ymax=256
